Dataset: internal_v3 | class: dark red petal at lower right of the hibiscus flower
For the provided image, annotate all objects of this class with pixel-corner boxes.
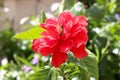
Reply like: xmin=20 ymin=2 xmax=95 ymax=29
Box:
xmin=71 ymin=44 xmax=88 ymax=59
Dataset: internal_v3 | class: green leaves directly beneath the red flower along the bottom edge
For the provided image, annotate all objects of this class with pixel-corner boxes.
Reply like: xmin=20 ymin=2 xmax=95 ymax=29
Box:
xmin=27 ymin=50 xmax=98 ymax=80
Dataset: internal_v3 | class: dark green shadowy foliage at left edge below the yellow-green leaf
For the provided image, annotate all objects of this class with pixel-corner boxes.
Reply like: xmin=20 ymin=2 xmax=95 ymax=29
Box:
xmin=0 ymin=29 xmax=32 ymax=61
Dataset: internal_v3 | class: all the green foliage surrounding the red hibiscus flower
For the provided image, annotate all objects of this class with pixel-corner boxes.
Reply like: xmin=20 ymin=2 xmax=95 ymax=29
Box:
xmin=0 ymin=0 xmax=120 ymax=80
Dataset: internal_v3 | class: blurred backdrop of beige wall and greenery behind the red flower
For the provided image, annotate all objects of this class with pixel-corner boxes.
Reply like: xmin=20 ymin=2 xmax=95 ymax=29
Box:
xmin=0 ymin=0 xmax=120 ymax=80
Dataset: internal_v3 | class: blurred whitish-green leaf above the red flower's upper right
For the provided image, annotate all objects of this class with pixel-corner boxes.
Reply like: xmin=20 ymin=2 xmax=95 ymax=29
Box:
xmin=70 ymin=2 xmax=85 ymax=15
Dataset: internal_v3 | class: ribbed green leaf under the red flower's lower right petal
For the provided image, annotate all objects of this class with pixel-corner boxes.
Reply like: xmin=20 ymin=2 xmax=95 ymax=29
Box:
xmin=79 ymin=50 xmax=98 ymax=80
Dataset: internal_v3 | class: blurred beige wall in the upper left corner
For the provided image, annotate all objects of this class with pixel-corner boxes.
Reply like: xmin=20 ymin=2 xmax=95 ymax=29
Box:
xmin=0 ymin=0 xmax=60 ymax=31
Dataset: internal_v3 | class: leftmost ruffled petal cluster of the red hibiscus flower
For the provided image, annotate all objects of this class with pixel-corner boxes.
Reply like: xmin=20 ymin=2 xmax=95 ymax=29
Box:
xmin=32 ymin=38 xmax=56 ymax=56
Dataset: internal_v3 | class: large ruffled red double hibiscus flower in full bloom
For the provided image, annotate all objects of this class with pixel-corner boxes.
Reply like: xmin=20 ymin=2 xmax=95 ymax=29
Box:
xmin=32 ymin=11 xmax=88 ymax=67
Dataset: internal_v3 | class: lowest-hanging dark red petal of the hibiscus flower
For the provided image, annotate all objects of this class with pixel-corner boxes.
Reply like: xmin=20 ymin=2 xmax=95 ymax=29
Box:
xmin=52 ymin=51 xmax=67 ymax=67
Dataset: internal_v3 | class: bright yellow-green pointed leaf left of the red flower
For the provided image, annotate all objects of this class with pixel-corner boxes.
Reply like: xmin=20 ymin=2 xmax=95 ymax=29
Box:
xmin=12 ymin=26 xmax=43 ymax=40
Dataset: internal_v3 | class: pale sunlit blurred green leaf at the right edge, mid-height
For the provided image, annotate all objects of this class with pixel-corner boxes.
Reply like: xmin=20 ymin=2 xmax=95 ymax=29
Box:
xmin=99 ymin=22 xmax=120 ymax=41
